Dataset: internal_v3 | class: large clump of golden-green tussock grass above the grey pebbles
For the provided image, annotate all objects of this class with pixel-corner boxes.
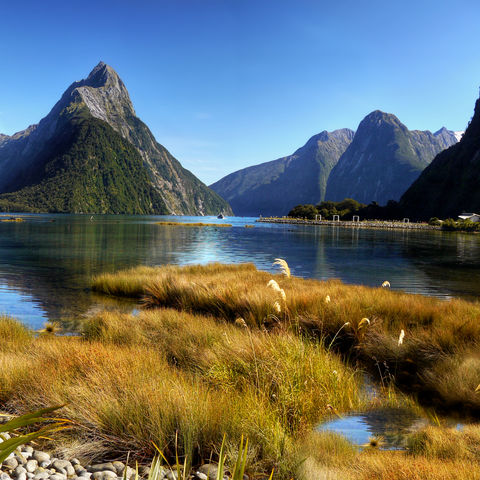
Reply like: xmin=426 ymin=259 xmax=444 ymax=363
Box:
xmin=0 ymin=309 xmax=367 ymax=479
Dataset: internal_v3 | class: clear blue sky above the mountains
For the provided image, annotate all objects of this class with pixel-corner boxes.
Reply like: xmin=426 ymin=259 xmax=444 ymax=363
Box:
xmin=0 ymin=0 xmax=480 ymax=184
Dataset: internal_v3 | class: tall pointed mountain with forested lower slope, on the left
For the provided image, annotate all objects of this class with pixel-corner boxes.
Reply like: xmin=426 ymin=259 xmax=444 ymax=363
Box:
xmin=0 ymin=62 xmax=231 ymax=215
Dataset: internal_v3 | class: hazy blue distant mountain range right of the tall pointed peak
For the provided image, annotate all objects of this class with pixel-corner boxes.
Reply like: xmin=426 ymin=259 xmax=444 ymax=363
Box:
xmin=210 ymin=110 xmax=463 ymax=216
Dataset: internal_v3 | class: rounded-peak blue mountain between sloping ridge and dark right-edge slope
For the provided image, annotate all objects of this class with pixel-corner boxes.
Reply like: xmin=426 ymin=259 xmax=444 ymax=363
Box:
xmin=325 ymin=110 xmax=457 ymax=205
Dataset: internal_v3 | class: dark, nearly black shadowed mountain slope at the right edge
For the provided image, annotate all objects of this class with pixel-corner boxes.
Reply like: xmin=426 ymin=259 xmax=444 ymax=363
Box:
xmin=400 ymin=99 xmax=480 ymax=220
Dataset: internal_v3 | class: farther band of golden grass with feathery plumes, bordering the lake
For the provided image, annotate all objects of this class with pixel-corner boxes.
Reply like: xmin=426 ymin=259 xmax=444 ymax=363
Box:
xmin=93 ymin=264 xmax=480 ymax=416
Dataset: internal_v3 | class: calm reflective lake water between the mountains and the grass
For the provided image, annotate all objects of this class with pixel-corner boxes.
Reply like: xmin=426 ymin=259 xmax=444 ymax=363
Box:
xmin=0 ymin=215 xmax=480 ymax=328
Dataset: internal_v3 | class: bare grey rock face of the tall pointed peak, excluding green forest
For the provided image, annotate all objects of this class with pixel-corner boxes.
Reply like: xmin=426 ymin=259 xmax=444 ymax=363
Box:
xmin=0 ymin=62 xmax=231 ymax=215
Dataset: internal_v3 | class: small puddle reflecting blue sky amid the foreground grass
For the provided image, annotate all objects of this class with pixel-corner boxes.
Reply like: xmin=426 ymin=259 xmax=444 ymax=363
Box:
xmin=317 ymin=408 xmax=461 ymax=450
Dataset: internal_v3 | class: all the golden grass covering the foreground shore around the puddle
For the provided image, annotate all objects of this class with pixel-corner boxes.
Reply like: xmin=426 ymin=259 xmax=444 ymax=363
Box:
xmin=0 ymin=261 xmax=480 ymax=480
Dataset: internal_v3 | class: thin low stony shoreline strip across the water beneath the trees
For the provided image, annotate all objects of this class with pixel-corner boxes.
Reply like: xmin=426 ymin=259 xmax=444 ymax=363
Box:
xmin=256 ymin=217 xmax=442 ymax=231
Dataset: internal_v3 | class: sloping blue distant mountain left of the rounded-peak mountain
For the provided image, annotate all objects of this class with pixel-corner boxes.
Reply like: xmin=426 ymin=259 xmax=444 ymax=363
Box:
xmin=210 ymin=128 xmax=354 ymax=216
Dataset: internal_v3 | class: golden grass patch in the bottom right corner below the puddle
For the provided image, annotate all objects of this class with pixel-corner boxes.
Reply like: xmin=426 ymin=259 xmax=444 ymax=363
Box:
xmin=295 ymin=426 xmax=480 ymax=480
